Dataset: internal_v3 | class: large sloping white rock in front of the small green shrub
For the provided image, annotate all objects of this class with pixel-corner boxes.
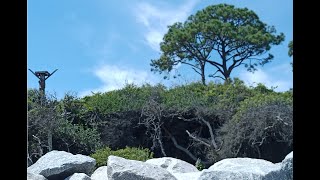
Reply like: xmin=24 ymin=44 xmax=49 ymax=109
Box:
xmin=107 ymin=156 xmax=177 ymax=180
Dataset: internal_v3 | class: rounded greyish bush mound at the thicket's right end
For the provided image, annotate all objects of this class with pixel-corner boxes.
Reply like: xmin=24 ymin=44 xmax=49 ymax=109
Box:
xmin=219 ymin=93 xmax=293 ymax=162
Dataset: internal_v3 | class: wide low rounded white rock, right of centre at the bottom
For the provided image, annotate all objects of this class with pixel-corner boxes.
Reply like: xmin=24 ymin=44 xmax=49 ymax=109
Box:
xmin=198 ymin=158 xmax=277 ymax=180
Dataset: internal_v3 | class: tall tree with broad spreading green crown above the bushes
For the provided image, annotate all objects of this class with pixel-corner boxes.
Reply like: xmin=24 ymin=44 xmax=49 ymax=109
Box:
xmin=151 ymin=4 xmax=284 ymax=84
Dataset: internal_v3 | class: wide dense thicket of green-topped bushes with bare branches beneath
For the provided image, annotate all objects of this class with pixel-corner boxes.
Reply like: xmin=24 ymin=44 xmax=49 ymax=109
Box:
xmin=28 ymin=79 xmax=292 ymax=166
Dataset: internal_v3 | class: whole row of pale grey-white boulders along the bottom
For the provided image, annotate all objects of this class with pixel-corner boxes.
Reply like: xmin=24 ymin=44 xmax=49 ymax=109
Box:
xmin=27 ymin=151 xmax=293 ymax=180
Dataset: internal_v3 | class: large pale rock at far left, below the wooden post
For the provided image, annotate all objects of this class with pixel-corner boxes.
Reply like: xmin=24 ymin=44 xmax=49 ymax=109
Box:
xmin=27 ymin=150 xmax=96 ymax=180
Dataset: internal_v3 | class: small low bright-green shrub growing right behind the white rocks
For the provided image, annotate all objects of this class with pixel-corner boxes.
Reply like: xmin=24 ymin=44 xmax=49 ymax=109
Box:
xmin=90 ymin=147 xmax=153 ymax=168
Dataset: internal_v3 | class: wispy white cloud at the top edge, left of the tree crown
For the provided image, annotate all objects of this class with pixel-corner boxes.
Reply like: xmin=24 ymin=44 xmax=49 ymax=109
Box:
xmin=134 ymin=0 xmax=199 ymax=51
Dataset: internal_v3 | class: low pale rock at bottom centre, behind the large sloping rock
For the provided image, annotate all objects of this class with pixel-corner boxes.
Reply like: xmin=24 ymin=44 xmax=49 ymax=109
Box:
xmin=146 ymin=157 xmax=199 ymax=173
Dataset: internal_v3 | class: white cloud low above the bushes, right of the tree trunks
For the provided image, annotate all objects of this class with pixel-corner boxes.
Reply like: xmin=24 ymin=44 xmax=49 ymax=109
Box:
xmin=239 ymin=69 xmax=292 ymax=92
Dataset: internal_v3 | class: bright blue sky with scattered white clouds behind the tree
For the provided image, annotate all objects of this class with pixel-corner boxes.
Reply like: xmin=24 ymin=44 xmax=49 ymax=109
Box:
xmin=26 ymin=0 xmax=293 ymax=97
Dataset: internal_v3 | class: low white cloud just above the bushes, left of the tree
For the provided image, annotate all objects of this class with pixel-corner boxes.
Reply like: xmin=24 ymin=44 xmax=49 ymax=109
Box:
xmin=80 ymin=65 xmax=157 ymax=97
